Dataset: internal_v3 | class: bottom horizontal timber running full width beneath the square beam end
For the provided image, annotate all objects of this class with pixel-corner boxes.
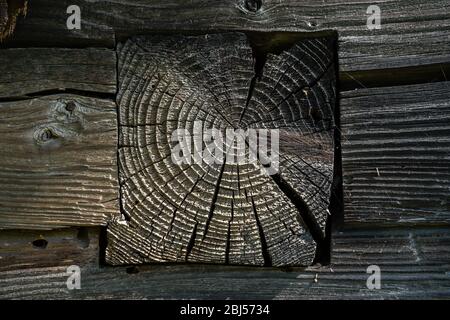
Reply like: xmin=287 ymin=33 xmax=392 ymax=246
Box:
xmin=0 ymin=228 xmax=450 ymax=298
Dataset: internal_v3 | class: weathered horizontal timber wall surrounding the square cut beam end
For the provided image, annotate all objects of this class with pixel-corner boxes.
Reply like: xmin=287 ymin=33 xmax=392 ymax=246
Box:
xmin=0 ymin=0 xmax=450 ymax=299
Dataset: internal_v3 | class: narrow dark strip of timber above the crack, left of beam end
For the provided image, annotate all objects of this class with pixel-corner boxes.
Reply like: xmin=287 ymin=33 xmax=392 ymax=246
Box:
xmin=0 ymin=48 xmax=116 ymax=98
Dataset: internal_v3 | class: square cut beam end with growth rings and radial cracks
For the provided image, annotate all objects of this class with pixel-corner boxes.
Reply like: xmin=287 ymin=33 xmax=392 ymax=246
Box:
xmin=107 ymin=33 xmax=336 ymax=266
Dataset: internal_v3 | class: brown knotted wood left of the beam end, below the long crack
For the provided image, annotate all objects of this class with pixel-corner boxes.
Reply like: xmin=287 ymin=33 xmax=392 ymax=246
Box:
xmin=0 ymin=95 xmax=118 ymax=229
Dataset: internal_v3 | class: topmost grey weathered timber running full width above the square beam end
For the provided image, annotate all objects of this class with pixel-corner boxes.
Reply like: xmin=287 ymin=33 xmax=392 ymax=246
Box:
xmin=6 ymin=0 xmax=450 ymax=71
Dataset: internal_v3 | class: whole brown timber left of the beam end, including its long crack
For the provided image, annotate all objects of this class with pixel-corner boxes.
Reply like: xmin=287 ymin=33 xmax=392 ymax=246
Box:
xmin=0 ymin=48 xmax=119 ymax=229
